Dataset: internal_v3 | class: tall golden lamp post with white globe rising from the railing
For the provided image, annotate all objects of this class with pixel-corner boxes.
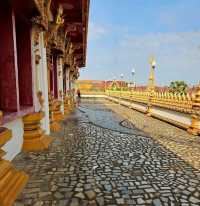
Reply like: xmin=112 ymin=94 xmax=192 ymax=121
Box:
xmin=146 ymin=58 xmax=156 ymax=116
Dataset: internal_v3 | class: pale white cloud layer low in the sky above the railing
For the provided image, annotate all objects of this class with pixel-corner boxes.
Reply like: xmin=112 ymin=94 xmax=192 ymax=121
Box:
xmin=82 ymin=31 xmax=200 ymax=85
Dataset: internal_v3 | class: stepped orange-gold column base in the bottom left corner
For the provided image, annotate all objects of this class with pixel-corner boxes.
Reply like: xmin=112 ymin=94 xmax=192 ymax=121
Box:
xmin=0 ymin=111 xmax=29 ymax=206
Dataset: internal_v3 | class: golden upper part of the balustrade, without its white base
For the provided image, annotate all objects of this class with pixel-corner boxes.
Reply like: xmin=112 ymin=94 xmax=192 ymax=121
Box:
xmin=106 ymin=88 xmax=200 ymax=135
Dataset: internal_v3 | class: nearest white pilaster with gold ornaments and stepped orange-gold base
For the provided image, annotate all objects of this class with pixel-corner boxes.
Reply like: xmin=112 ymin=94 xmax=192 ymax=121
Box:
xmin=22 ymin=29 xmax=53 ymax=151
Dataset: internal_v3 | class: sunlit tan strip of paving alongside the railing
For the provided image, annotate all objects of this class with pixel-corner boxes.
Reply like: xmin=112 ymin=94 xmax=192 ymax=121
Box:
xmin=106 ymin=99 xmax=200 ymax=170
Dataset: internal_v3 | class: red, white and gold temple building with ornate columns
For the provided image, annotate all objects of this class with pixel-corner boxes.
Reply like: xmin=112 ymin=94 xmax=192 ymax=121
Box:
xmin=0 ymin=0 xmax=89 ymax=206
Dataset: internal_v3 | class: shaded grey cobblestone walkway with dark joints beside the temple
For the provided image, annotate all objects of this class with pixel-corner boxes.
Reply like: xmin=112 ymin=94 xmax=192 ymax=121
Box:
xmin=13 ymin=99 xmax=200 ymax=206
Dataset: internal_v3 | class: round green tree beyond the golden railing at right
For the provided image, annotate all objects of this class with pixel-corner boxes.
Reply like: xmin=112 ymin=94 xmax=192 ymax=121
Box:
xmin=169 ymin=81 xmax=188 ymax=94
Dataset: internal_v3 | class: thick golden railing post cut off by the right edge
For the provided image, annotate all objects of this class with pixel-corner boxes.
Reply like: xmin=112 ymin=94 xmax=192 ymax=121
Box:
xmin=188 ymin=84 xmax=200 ymax=135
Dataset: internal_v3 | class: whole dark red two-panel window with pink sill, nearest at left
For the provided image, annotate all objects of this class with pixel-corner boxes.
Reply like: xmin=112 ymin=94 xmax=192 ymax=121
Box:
xmin=0 ymin=1 xmax=33 ymax=120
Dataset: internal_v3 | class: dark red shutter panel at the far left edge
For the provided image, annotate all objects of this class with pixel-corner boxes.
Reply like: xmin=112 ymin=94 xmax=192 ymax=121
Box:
xmin=0 ymin=1 xmax=19 ymax=112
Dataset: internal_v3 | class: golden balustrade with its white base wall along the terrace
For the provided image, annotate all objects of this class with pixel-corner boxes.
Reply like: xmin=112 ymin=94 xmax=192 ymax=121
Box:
xmin=106 ymin=87 xmax=200 ymax=135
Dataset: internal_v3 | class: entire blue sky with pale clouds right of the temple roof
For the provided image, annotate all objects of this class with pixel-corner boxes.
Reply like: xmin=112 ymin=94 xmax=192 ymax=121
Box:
xmin=80 ymin=0 xmax=200 ymax=85
